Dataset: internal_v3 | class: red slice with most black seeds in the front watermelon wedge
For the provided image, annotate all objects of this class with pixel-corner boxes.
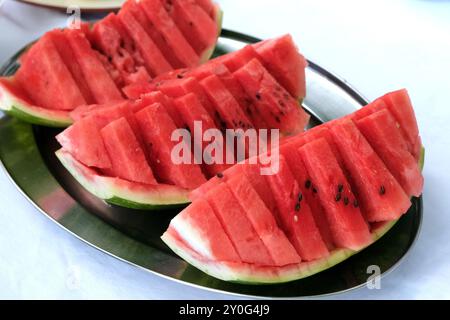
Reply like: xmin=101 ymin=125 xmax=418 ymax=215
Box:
xmin=299 ymin=138 xmax=372 ymax=250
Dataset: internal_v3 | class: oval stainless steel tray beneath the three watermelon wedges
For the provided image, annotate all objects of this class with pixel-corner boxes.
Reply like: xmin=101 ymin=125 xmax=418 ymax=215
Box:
xmin=0 ymin=30 xmax=422 ymax=297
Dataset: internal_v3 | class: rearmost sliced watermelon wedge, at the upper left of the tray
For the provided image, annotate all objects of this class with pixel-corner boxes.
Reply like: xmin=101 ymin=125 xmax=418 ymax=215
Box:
xmin=0 ymin=0 xmax=222 ymax=127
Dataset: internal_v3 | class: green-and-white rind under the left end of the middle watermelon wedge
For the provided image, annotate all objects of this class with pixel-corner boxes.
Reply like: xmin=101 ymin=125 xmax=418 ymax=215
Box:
xmin=55 ymin=149 xmax=189 ymax=210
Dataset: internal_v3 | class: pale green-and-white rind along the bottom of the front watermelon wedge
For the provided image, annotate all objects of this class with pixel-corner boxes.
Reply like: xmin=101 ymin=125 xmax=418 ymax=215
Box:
xmin=161 ymin=147 xmax=425 ymax=285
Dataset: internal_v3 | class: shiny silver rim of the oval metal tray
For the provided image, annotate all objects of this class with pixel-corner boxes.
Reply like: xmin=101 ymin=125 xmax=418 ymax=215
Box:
xmin=0 ymin=29 xmax=423 ymax=300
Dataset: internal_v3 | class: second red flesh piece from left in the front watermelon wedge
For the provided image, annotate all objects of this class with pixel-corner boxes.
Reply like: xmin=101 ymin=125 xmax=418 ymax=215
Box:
xmin=205 ymin=183 xmax=275 ymax=266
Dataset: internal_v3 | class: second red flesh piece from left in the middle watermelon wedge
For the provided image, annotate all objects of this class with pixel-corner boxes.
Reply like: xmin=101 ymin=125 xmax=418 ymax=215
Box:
xmin=100 ymin=118 xmax=157 ymax=184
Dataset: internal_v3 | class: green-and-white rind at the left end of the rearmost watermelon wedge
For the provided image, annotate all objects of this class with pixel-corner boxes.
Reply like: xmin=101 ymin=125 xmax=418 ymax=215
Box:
xmin=0 ymin=79 xmax=73 ymax=128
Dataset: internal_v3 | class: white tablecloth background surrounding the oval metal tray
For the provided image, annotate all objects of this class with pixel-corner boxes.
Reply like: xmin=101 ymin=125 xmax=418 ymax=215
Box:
xmin=0 ymin=0 xmax=450 ymax=299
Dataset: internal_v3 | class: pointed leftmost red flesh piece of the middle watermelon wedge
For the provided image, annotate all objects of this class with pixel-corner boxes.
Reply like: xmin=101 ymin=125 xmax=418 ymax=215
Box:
xmin=56 ymin=116 xmax=111 ymax=169
